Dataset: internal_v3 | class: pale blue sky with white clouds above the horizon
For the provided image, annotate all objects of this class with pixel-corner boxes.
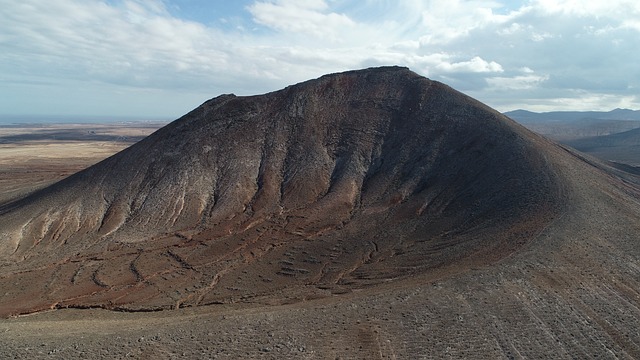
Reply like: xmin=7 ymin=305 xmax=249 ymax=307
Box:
xmin=0 ymin=0 xmax=640 ymax=119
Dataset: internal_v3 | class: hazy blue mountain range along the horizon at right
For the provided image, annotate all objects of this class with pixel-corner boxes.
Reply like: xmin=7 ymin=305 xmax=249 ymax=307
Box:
xmin=504 ymin=109 xmax=640 ymax=123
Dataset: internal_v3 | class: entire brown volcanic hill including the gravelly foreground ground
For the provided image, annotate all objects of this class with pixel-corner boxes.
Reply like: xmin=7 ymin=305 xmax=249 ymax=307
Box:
xmin=0 ymin=67 xmax=640 ymax=359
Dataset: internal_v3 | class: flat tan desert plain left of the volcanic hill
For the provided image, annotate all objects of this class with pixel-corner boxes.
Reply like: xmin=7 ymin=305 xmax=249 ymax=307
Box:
xmin=0 ymin=122 xmax=166 ymax=204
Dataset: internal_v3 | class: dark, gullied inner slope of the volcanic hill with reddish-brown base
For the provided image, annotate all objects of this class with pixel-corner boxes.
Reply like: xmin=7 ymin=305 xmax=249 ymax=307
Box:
xmin=0 ymin=67 xmax=564 ymax=316
